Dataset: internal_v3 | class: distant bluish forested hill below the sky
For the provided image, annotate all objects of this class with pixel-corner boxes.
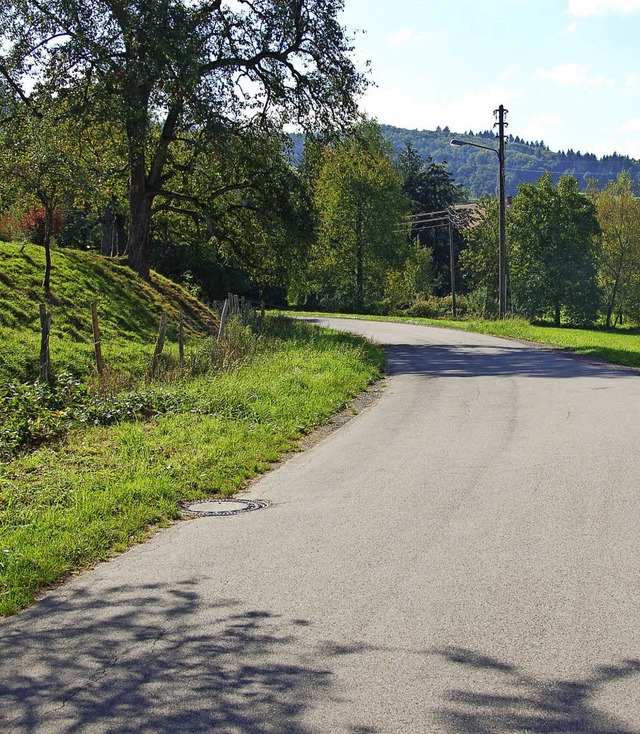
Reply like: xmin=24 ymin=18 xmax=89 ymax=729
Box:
xmin=381 ymin=125 xmax=640 ymax=198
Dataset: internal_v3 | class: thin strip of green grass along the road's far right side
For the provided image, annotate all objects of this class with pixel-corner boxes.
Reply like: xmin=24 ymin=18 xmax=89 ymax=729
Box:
xmin=284 ymin=312 xmax=640 ymax=367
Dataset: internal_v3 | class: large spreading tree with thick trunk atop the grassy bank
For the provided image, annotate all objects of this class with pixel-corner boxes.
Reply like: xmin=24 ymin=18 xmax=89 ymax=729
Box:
xmin=0 ymin=0 xmax=364 ymax=277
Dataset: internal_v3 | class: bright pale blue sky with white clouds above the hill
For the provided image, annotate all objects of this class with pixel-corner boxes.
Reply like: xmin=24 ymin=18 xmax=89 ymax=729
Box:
xmin=340 ymin=0 xmax=640 ymax=159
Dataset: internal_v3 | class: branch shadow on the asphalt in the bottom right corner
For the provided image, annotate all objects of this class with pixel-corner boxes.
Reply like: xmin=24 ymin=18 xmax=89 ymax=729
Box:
xmin=437 ymin=647 xmax=640 ymax=734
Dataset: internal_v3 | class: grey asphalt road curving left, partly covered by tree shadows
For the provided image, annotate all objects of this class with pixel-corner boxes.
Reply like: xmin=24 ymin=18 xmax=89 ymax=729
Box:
xmin=0 ymin=321 xmax=640 ymax=734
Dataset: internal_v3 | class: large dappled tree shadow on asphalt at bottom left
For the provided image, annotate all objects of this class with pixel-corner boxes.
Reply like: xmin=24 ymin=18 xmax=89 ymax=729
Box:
xmin=0 ymin=581 xmax=330 ymax=734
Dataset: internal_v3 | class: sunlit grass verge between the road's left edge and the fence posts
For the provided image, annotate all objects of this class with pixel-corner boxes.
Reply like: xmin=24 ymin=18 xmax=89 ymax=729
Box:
xmin=0 ymin=323 xmax=383 ymax=616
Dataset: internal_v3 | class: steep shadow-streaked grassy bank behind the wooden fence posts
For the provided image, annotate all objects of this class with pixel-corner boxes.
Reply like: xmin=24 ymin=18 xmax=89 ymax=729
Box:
xmin=0 ymin=242 xmax=218 ymax=385
